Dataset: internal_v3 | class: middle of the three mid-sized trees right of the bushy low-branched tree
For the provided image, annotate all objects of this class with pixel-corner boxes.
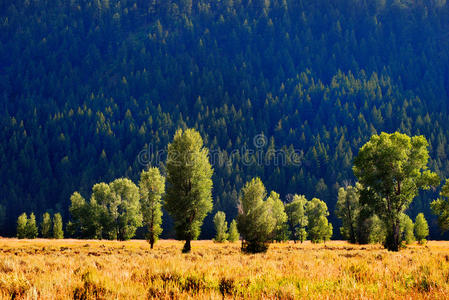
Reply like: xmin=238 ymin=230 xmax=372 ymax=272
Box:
xmin=285 ymin=195 xmax=309 ymax=243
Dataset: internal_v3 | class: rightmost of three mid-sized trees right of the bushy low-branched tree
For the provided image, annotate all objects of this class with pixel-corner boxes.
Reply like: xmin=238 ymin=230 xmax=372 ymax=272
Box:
xmin=306 ymin=198 xmax=333 ymax=243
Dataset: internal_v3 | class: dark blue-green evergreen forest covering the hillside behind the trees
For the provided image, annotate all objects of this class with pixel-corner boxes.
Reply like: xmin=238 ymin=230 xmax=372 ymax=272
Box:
xmin=0 ymin=0 xmax=449 ymax=238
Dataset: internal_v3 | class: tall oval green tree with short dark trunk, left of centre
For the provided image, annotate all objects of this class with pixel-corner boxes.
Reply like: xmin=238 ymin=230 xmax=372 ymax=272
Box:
xmin=165 ymin=129 xmax=213 ymax=253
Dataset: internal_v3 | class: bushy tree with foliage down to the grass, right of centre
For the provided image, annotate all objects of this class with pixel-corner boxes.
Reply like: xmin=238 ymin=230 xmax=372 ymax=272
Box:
xmin=237 ymin=178 xmax=276 ymax=253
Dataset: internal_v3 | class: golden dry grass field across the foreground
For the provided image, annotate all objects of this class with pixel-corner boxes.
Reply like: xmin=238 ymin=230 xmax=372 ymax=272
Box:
xmin=0 ymin=239 xmax=449 ymax=299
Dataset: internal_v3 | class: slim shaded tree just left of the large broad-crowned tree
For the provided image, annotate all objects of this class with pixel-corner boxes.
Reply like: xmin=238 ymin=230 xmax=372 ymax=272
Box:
xmin=335 ymin=184 xmax=361 ymax=243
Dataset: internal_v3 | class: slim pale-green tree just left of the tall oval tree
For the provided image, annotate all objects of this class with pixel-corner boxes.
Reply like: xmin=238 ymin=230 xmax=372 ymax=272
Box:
xmin=139 ymin=167 xmax=165 ymax=249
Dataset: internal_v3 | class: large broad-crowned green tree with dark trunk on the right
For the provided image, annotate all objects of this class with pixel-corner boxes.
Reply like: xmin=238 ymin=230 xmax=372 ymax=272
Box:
xmin=353 ymin=132 xmax=439 ymax=251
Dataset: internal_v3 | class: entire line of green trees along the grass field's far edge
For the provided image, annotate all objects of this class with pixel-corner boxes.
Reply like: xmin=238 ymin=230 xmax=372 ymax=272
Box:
xmin=17 ymin=129 xmax=449 ymax=253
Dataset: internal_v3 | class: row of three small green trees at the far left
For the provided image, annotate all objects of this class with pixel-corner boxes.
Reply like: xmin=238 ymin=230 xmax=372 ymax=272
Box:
xmin=17 ymin=212 xmax=64 ymax=239
